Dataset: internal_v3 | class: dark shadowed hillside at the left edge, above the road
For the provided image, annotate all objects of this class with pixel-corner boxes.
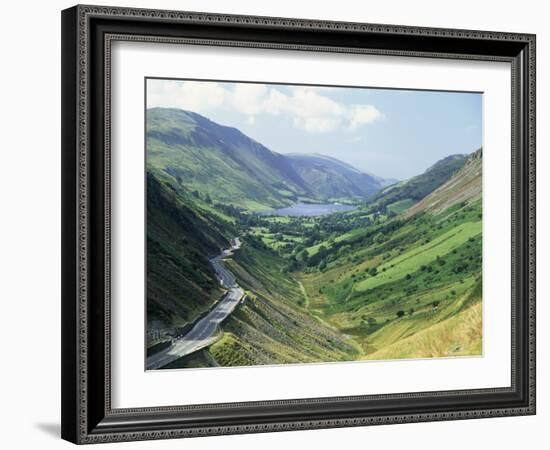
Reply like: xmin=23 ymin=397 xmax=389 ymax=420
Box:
xmin=147 ymin=172 xmax=233 ymax=344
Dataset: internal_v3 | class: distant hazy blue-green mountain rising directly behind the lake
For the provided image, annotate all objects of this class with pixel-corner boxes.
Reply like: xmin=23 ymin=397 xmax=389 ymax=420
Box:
xmin=286 ymin=153 xmax=383 ymax=199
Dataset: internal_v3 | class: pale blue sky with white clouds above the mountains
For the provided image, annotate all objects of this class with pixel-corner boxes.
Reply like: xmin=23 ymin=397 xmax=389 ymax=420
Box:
xmin=147 ymin=79 xmax=483 ymax=180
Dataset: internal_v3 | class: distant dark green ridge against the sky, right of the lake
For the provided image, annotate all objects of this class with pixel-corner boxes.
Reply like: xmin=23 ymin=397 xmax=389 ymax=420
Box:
xmin=369 ymin=155 xmax=468 ymax=213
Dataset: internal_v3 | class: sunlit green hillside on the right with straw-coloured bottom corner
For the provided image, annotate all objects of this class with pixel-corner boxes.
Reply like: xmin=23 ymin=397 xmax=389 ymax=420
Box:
xmin=296 ymin=150 xmax=482 ymax=359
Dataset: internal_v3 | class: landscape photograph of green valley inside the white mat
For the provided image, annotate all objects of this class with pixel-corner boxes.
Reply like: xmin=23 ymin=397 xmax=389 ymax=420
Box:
xmin=146 ymin=78 xmax=483 ymax=370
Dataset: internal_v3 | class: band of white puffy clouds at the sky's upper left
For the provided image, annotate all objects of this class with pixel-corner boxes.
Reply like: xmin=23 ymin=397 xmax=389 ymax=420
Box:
xmin=147 ymin=80 xmax=383 ymax=133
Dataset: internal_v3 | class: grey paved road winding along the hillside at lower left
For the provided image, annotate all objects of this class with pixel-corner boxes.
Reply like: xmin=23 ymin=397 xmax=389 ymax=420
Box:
xmin=147 ymin=238 xmax=244 ymax=370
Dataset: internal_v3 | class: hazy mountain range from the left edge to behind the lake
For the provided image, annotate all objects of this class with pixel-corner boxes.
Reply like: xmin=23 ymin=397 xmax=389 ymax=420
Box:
xmin=146 ymin=108 xmax=383 ymax=209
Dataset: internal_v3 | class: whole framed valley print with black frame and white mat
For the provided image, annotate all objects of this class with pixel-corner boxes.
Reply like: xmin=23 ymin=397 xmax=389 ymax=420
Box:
xmin=62 ymin=6 xmax=535 ymax=443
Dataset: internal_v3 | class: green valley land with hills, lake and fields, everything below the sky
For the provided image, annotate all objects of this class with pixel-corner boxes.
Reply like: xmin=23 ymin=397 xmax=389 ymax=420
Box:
xmin=147 ymin=108 xmax=482 ymax=369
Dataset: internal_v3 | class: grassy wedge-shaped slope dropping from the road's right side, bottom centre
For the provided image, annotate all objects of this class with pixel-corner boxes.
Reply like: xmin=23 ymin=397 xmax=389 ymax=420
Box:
xmin=172 ymin=238 xmax=358 ymax=367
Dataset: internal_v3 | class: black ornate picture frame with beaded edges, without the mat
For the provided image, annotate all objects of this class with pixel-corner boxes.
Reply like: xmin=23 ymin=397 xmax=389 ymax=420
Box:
xmin=62 ymin=6 xmax=535 ymax=444
